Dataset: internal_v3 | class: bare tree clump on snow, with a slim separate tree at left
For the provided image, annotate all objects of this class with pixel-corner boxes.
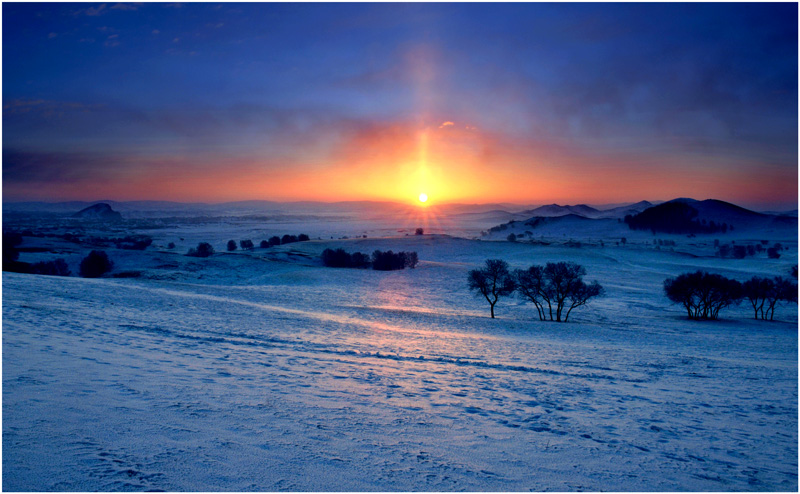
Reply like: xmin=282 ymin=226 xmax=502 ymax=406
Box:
xmin=467 ymin=259 xmax=604 ymax=322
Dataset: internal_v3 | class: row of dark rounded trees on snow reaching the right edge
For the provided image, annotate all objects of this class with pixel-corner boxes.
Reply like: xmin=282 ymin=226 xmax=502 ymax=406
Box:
xmin=664 ymin=271 xmax=797 ymax=321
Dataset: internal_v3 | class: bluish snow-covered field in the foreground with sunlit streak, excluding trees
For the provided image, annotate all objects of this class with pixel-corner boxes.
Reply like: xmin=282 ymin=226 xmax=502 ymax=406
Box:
xmin=3 ymin=208 xmax=798 ymax=491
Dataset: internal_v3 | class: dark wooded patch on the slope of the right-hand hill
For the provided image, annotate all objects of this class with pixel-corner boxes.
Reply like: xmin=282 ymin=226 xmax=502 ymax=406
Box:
xmin=624 ymin=202 xmax=733 ymax=234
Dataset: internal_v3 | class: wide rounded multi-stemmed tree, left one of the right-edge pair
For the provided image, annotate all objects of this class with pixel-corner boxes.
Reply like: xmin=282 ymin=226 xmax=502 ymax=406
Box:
xmin=664 ymin=271 xmax=744 ymax=319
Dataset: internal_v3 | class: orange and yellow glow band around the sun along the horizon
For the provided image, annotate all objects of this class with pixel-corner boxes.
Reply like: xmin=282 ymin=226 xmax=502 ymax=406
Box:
xmin=3 ymin=119 xmax=797 ymax=211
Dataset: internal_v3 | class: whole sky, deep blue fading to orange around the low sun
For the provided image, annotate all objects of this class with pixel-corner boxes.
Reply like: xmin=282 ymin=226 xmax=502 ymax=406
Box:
xmin=2 ymin=3 xmax=798 ymax=209
